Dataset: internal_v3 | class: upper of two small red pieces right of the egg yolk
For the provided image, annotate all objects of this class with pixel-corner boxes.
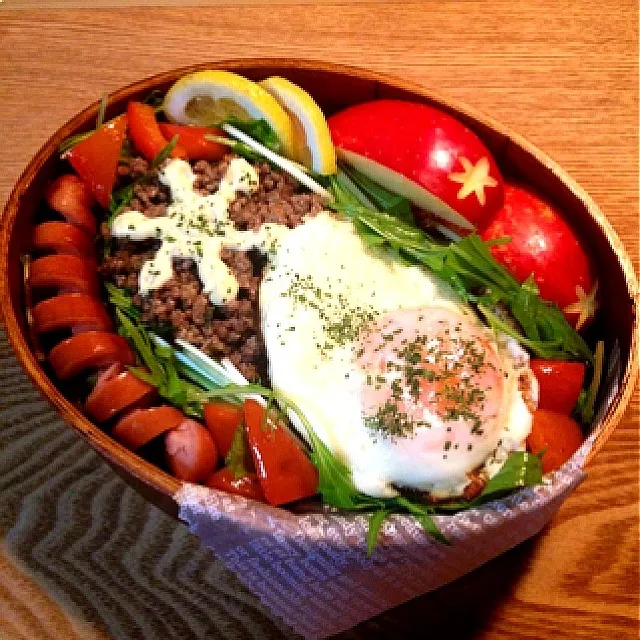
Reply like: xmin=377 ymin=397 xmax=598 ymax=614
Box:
xmin=530 ymin=358 xmax=586 ymax=416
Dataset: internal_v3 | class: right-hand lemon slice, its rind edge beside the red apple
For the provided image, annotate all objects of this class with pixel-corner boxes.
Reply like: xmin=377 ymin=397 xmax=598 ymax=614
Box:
xmin=260 ymin=76 xmax=337 ymax=175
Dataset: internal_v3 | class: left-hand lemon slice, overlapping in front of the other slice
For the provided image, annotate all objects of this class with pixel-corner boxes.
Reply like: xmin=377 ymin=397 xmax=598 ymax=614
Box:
xmin=164 ymin=71 xmax=293 ymax=157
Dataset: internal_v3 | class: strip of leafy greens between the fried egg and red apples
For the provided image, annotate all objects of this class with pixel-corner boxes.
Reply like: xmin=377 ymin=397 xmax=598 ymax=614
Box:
xmin=329 ymin=195 xmax=593 ymax=361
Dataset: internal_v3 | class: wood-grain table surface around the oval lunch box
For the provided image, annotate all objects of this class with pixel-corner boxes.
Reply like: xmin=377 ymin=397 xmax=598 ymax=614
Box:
xmin=0 ymin=0 xmax=639 ymax=640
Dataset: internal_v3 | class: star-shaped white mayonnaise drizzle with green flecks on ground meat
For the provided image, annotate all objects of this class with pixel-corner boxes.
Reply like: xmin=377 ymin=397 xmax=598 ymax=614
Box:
xmin=111 ymin=158 xmax=288 ymax=304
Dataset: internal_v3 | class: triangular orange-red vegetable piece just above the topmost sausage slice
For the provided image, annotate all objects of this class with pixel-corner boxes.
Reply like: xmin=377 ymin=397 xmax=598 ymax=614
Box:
xmin=66 ymin=114 xmax=127 ymax=209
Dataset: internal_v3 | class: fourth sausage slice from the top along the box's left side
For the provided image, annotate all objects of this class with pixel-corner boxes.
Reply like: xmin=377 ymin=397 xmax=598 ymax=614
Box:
xmin=32 ymin=293 xmax=113 ymax=333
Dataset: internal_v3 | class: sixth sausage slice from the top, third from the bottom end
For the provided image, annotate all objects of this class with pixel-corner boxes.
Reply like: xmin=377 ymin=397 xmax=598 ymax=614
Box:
xmin=84 ymin=365 xmax=156 ymax=422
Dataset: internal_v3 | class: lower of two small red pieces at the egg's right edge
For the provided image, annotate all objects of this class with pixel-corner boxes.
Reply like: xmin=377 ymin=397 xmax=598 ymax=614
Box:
xmin=527 ymin=410 xmax=582 ymax=473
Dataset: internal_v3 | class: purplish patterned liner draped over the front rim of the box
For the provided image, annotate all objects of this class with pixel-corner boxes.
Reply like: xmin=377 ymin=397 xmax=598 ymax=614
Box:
xmin=175 ymin=345 xmax=620 ymax=638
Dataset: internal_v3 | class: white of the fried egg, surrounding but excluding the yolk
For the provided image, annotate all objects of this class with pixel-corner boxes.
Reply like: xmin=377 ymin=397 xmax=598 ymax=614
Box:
xmin=260 ymin=212 xmax=531 ymax=498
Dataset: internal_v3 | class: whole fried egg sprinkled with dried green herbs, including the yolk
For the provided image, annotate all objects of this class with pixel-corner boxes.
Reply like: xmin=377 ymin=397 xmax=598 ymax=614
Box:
xmin=260 ymin=212 xmax=537 ymax=498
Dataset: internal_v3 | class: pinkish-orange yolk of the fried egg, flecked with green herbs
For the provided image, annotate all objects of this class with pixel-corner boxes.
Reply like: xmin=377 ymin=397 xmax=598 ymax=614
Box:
xmin=356 ymin=307 xmax=504 ymax=440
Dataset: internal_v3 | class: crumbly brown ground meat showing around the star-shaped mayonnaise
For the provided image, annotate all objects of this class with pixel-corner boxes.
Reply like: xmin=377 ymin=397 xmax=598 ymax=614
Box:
xmin=101 ymin=155 xmax=322 ymax=380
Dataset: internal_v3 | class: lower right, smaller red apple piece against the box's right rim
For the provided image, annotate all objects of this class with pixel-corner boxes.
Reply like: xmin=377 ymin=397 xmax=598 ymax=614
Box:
xmin=482 ymin=185 xmax=593 ymax=322
